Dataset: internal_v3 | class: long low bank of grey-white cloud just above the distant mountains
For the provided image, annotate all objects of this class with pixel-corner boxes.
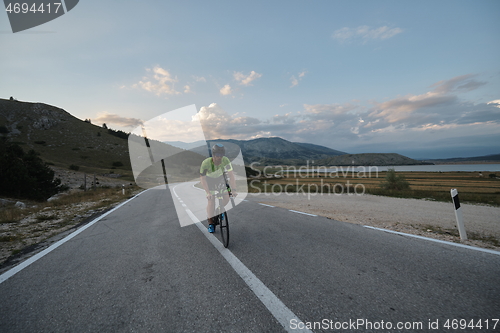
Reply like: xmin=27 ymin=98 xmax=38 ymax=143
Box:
xmin=187 ymin=75 xmax=500 ymax=157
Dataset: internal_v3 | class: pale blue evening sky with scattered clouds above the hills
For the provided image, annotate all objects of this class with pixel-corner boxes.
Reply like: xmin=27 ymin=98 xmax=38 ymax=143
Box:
xmin=0 ymin=0 xmax=500 ymax=159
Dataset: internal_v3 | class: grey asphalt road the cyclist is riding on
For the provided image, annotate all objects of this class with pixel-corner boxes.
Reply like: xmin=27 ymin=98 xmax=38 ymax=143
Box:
xmin=0 ymin=185 xmax=500 ymax=332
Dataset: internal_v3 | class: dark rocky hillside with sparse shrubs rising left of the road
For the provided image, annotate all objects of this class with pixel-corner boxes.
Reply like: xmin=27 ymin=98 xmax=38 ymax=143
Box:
xmin=0 ymin=99 xmax=134 ymax=170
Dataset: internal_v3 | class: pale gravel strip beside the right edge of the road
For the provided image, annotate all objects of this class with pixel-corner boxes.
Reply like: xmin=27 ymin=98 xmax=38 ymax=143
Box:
xmin=254 ymin=193 xmax=500 ymax=251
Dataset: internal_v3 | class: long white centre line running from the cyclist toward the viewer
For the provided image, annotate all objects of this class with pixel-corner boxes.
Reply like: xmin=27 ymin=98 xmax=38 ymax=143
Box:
xmin=173 ymin=186 xmax=312 ymax=333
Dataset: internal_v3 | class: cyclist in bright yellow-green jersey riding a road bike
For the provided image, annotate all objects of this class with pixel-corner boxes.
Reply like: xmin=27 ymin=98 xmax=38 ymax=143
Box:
xmin=200 ymin=143 xmax=238 ymax=233
